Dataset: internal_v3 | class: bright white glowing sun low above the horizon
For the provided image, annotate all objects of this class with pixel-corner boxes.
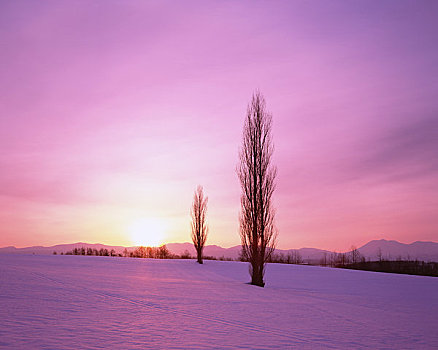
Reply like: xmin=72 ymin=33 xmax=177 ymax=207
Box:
xmin=128 ymin=218 xmax=166 ymax=247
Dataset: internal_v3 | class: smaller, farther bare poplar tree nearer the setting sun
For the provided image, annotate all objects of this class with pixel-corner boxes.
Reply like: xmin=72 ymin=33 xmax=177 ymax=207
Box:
xmin=190 ymin=186 xmax=208 ymax=264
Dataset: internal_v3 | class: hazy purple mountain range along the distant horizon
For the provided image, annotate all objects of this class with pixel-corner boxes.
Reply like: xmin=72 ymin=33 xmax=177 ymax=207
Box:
xmin=0 ymin=239 xmax=438 ymax=263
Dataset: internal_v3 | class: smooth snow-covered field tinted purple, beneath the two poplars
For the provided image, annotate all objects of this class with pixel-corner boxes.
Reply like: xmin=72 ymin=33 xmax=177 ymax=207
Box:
xmin=0 ymin=255 xmax=438 ymax=349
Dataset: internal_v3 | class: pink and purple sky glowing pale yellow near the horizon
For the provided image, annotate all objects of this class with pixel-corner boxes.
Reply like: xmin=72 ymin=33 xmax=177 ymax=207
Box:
xmin=0 ymin=0 xmax=438 ymax=251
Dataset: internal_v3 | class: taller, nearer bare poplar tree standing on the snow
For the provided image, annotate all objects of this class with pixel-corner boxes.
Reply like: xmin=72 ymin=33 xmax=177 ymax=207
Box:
xmin=237 ymin=91 xmax=277 ymax=287
